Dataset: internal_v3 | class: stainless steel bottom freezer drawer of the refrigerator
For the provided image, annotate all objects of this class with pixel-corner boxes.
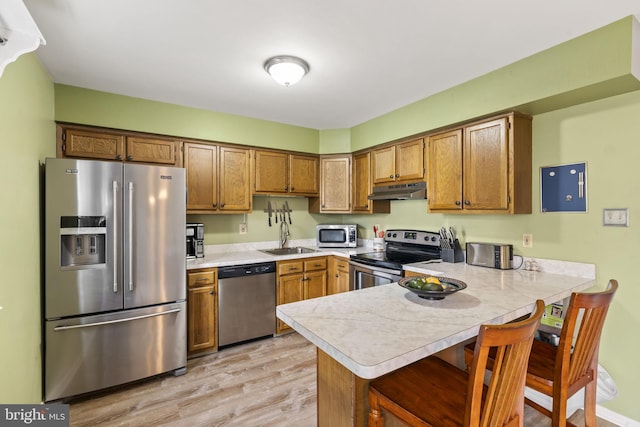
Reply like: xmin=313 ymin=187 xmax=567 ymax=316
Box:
xmin=44 ymin=302 xmax=187 ymax=402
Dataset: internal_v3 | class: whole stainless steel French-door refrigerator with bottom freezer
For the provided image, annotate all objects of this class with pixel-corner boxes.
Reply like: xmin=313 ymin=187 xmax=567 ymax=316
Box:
xmin=44 ymin=159 xmax=187 ymax=402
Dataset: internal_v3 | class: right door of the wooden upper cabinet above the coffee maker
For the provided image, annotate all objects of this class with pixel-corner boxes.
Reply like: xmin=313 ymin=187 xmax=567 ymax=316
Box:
xmin=219 ymin=147 xmax=251 ymax=212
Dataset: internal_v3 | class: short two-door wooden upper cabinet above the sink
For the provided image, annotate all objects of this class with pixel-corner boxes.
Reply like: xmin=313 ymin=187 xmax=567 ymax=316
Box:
xmin=254 ymin=150 xmax=319 ymax=196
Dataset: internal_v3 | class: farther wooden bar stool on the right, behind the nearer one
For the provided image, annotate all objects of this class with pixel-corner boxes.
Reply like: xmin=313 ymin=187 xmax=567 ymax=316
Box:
xmin=465 ymin=279 xmax=618 ymax=427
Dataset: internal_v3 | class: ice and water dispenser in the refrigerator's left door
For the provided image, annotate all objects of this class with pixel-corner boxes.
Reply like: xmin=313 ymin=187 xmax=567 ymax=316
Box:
xmin=60 ymin=216 xmax=107 ymax=270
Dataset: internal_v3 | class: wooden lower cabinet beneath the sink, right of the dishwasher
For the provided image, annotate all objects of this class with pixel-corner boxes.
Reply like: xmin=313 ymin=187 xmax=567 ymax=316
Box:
xmin=276 ymin=257 xmax=327 ymax=334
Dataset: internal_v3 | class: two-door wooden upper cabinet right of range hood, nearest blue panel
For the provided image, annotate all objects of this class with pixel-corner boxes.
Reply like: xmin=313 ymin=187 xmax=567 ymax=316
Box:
xmin=427 ymin=113 xmax=531 ymax=214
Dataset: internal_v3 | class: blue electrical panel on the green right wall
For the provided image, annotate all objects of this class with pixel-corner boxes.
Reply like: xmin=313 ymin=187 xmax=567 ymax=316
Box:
xmin=540 ymin=163 xmax=587 ymax=212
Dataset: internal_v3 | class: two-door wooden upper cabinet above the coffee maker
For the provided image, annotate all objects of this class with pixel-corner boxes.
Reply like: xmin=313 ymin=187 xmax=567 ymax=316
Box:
xmin=184 ymin=142 xmax=251 ymax=213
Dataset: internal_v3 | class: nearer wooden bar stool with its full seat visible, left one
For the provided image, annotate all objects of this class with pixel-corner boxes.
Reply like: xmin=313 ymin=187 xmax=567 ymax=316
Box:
xmin=369 ymin=300 xmax=544 ymax=427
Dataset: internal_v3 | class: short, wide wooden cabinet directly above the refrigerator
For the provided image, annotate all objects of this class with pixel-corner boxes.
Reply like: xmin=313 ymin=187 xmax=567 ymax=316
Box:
xmin=57 ymin=125 xmax=182 ymax=166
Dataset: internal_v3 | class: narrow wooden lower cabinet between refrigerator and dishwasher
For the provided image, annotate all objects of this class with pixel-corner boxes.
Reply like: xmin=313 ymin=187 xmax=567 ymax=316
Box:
xmin=187 ymin=268 xmax=218 ymax=356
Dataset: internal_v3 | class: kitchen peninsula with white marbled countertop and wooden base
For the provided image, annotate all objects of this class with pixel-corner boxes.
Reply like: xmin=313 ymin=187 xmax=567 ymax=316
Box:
xmin=276 ymin=263 xmax=595 ymax=426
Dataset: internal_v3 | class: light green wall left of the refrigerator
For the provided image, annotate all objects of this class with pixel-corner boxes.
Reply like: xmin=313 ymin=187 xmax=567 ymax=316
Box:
xmin=0 ymin=54 xmax=55 ymax=403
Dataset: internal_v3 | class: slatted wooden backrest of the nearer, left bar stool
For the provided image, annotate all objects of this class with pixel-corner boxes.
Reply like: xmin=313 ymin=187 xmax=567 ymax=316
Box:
xmin=465 ymin=300 xmax=544 ymax=427
